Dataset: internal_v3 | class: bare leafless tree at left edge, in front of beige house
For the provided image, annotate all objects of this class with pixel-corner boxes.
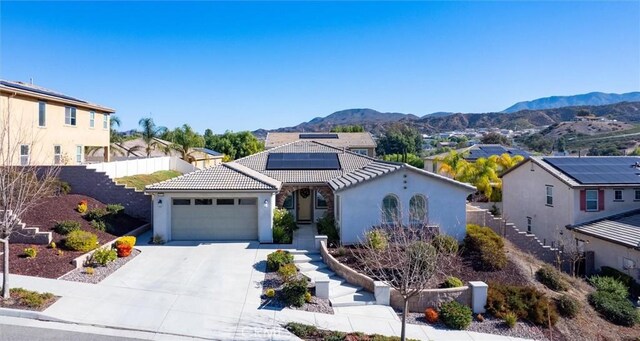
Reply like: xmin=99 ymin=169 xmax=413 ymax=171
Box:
xmin=0 ymin=97 xmax=58 ymax=298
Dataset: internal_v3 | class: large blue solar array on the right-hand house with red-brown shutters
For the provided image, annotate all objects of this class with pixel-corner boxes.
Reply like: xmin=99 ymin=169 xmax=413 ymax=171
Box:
xmin=544 ymin=156 xmax=640 ymax=184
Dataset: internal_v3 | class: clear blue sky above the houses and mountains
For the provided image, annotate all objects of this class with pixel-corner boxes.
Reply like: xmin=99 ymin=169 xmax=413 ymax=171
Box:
xmin=0 ymin=1 xmax=640 ymax=133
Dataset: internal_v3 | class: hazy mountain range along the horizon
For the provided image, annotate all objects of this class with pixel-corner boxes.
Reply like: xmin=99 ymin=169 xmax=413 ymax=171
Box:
xmin=253 ymin=92 xmax=640 ymax=138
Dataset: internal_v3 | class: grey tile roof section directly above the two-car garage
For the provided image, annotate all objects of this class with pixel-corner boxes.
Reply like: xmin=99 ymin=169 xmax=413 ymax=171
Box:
xmin=146 ymin=162 xmax=282 ymax=192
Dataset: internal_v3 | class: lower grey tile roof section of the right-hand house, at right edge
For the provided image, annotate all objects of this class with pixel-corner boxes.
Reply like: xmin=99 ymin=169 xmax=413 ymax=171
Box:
xmin=568 ymin=210 xmax=640 ymax=250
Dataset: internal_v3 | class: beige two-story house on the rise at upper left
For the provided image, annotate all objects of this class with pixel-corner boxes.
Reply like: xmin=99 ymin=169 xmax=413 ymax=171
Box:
xmin=0 ymin=80 xmax=115 ymax=165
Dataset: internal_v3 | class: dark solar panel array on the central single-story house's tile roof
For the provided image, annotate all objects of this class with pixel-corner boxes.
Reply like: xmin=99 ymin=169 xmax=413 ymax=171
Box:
xmin=267 ymin=153 xmax=340 ymax=170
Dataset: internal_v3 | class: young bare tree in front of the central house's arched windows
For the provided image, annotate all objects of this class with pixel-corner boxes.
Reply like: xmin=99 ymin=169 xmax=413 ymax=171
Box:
xmin=354 ymin=218 xmax=449 ymax=341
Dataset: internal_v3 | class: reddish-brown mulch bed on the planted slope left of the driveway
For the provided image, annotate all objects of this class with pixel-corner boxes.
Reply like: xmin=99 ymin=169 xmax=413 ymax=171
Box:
xmin=0 ymin=194 xmax=144 ymax=278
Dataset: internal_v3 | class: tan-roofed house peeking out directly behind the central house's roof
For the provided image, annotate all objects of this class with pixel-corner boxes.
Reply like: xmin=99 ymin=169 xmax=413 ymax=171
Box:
xmin=264 ymin=132 xmax=376 ymax=157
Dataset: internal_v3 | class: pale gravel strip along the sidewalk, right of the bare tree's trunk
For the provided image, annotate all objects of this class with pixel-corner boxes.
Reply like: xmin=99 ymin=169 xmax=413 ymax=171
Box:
xmin=398 ymin=313 xmax=548 ymax=340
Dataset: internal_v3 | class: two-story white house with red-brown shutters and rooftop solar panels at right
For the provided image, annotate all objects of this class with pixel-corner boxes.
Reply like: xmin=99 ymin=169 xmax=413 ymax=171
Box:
xmin=502 ymin=156 xmax=640 ymax=278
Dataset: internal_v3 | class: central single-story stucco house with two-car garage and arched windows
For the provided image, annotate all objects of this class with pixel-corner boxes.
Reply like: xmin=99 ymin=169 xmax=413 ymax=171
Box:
xmin=146 ymin=141 xmax=476 ymax=244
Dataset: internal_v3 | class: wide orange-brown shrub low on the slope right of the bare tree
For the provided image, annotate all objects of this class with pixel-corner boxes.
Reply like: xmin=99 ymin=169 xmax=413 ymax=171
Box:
xmin=486 ymin=283 xmax=558 ymax=327
